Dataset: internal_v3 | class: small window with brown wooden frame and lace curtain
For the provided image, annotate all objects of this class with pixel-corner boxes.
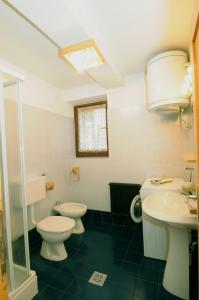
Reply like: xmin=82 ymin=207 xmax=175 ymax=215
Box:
xmin=74 ymin=101 xmax=109 ymax=157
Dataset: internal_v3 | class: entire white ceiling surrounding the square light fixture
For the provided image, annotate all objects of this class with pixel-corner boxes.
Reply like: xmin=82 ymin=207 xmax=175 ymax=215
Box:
xmin=0 ymin=0 xmax=197 ymax=88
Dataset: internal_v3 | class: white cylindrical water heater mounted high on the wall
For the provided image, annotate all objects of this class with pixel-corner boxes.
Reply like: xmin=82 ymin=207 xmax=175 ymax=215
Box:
xmin=146 ymin=51 xmax=190 ymax=112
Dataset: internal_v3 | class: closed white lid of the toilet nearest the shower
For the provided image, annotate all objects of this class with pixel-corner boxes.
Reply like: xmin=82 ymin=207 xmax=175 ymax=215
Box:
xmin=37 ymin=216 xmax=75 ymax=232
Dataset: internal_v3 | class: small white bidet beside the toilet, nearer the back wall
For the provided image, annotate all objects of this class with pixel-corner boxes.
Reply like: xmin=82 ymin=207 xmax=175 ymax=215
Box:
xmin=54 ymin=202 xmax=87 ymax=234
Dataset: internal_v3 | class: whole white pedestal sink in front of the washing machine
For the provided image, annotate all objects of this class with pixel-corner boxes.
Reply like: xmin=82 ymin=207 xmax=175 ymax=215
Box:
xmin=142 ymin=192 xmax=197 ymax=300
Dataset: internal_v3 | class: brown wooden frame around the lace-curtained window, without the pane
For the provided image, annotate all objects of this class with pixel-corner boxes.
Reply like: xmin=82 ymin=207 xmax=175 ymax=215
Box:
xmin=74 ymin=100 xmax=109 ymax=157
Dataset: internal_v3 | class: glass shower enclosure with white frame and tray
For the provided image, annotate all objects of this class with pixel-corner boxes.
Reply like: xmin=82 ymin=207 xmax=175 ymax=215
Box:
xmin=0 ymin=66 xmax=37 ymax=300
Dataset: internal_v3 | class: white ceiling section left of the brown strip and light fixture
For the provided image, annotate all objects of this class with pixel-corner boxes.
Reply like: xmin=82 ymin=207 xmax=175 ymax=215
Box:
xmin=0 ymin=1 xmax=93 ymax=89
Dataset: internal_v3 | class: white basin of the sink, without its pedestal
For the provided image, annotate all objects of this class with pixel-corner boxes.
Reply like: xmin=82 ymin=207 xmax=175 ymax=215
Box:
xmin=142 ymin=192 xmax=197 ymax=229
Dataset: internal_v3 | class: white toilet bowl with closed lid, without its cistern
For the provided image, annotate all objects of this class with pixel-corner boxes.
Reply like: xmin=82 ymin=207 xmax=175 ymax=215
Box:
xmin=36 ymin=216 xmax=75 ymax=261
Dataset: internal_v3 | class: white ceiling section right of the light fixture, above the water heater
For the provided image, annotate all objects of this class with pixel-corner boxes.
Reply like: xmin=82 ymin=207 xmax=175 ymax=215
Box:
xmin=65 ymin=0 xmax=197 ymax=76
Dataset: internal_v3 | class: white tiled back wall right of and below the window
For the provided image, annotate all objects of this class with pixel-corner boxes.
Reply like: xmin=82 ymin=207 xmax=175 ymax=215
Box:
xmin=66 ymin=73 xmax=193 ymax=211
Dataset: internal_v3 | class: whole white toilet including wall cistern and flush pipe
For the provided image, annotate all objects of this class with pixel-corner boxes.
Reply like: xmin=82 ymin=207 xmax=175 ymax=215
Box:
xmin=26 ymin=176 xmax=75 ymax=261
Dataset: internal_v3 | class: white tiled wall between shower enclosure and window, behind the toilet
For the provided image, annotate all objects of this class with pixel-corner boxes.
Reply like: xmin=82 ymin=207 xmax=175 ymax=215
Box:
xmin=24 ymin=105 xmax=73 ymax=231
